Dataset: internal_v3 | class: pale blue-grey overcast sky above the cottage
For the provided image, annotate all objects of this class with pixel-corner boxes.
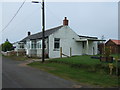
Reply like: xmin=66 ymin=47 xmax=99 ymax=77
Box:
xmin=0 ymin=0 xmax=118 ymax=43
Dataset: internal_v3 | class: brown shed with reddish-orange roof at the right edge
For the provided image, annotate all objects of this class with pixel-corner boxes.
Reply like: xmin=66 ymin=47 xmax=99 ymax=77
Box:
xmin=105 ymin=39 xmax=120 ymax=54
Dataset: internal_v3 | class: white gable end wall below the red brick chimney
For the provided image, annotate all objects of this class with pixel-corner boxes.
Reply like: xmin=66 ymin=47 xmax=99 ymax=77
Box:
xmin=49 ymin=26 xmax=82 ymax=58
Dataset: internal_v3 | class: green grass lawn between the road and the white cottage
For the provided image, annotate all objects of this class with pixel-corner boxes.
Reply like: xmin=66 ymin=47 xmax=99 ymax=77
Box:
xmin=28 ymin=56 xmax=118 ymax=87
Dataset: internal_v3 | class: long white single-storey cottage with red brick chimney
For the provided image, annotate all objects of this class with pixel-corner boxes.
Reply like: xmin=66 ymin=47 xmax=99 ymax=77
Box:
xmin=14 ymin=17 xmax=104 ymax=58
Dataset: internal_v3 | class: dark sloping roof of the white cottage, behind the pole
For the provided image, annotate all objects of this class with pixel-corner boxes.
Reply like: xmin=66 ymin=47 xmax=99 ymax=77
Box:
xmin=20 ymin=25 xmax=63 ymax=42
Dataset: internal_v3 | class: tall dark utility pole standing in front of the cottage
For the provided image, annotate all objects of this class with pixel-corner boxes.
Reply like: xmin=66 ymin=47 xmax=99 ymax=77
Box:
xmin=42 ymin=0 xmax=45 ymax=62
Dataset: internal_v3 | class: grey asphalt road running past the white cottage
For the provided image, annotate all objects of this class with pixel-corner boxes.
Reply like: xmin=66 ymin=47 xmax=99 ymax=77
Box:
xmin=2 ymin=57 xmax=79 ymax=88
